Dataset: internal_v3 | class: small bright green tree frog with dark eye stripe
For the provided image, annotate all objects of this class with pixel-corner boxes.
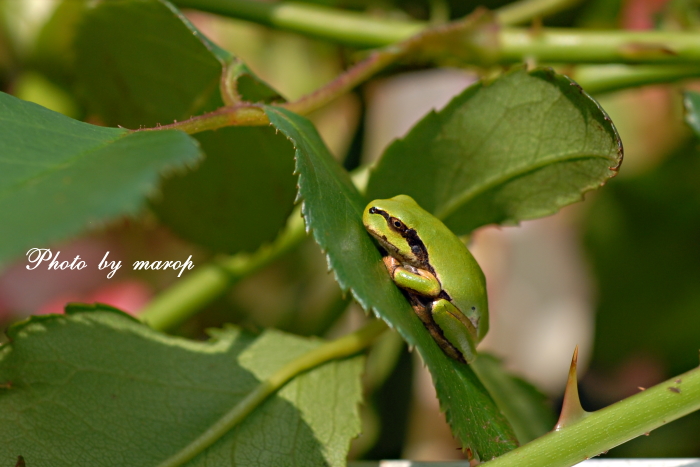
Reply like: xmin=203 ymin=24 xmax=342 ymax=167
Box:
xmin=362 ymin=195 xmax=489 ymax=363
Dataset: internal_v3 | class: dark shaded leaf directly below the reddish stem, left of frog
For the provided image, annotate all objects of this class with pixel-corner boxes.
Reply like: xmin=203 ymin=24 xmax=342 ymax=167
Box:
xmin=153 ymin=127 xmax=296 ymax=253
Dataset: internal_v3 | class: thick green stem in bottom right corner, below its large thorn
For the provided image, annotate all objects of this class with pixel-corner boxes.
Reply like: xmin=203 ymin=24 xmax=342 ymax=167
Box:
xmin=484 ymin=368 xmax=700 ymax=467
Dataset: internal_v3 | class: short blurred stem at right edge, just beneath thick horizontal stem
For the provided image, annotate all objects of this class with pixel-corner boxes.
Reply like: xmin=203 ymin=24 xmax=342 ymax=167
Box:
xmin=566 ymin=65 xmax=700 ymax=94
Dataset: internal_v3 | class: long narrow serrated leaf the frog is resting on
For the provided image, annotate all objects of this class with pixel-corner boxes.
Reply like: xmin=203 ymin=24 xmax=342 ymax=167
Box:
xmin=267 ymin=107 xmax=517 ymax=460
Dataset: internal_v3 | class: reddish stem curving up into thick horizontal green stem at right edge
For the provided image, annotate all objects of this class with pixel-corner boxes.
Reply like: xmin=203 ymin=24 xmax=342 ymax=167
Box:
xmin=144 ymin=22 xmax=700 ymax=134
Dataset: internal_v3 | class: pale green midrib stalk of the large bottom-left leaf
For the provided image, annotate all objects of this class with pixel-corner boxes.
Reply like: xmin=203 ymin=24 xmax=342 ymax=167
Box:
xmin=158 ymin=319 xmax=388 ymax=467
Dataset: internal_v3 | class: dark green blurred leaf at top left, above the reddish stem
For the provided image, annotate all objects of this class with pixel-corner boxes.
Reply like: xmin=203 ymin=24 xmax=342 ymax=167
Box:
xmin=74 ymin=0 xmax=233 ymax=128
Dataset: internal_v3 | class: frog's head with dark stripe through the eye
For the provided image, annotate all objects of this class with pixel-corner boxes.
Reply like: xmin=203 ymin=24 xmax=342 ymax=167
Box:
xmin=362 ymin=195 xmax=428 ymax=268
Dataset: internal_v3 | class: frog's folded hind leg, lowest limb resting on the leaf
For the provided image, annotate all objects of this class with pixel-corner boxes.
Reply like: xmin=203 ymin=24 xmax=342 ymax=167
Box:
xmin=431 ymin=298 xmax=478 ymax=363
